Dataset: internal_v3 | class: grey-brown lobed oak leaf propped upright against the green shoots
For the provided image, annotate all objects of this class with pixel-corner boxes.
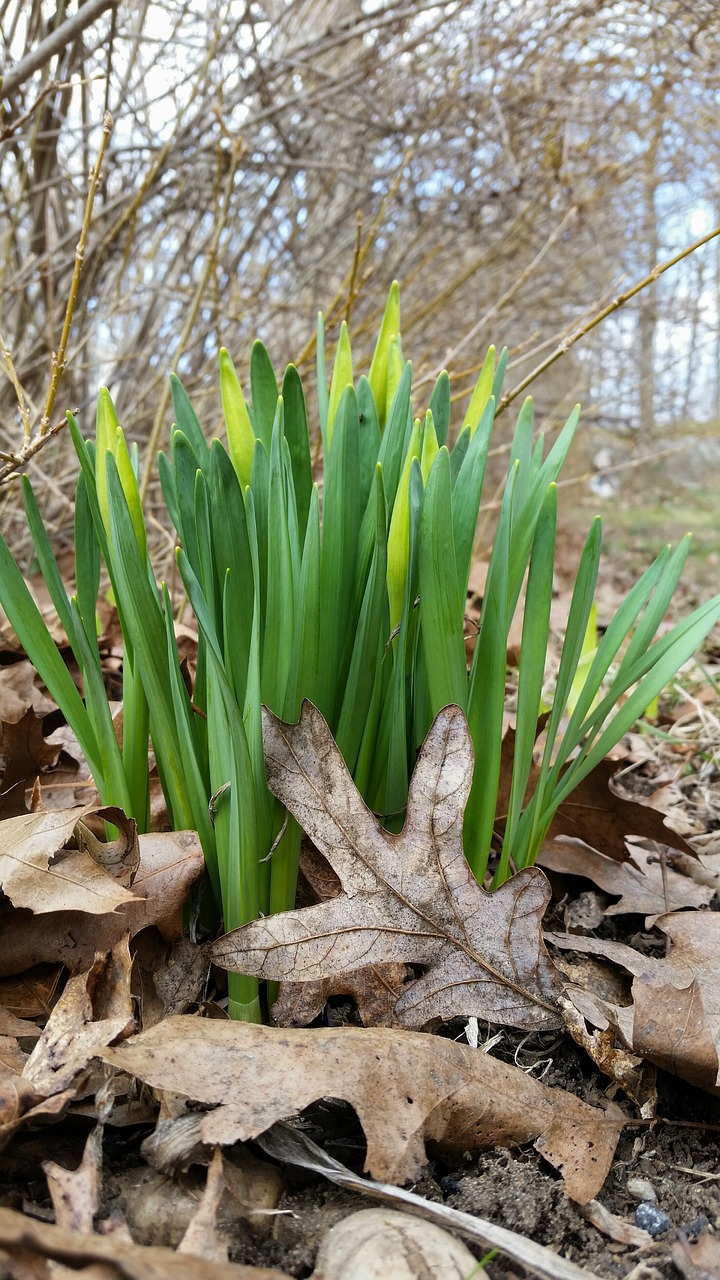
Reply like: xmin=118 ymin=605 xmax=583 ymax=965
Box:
xmin=211 ymin=701 xmax=562 ymax=1029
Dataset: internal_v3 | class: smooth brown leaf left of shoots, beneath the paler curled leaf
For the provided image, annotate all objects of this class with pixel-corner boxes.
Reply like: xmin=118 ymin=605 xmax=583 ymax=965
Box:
xmin=0 ymin=831 xmax=205 ymax=977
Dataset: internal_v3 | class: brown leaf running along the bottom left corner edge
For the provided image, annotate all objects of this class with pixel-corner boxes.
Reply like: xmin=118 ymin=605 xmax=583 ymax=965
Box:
xmin=0 ymin=1208 xmax=288 ymax=1280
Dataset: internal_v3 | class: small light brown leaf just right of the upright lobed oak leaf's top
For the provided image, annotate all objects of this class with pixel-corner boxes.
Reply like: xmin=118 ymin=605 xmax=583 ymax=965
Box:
xmin=538 ymin=838 xmax=714 ymax=915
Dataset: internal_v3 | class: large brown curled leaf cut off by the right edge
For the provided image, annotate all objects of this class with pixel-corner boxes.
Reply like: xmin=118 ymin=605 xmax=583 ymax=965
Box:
xmin=547 ymin=911 xmax=720 ymax=1094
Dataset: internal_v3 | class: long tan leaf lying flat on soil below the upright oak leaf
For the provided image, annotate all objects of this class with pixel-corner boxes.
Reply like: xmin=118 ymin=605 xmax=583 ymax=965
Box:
xmin=99 ymin=1016 xmax=623 ymax=1201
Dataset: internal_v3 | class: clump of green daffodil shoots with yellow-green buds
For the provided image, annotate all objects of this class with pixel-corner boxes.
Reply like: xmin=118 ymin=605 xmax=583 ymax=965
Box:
xmin=0 ymin=284 xmax=720 ymax=1019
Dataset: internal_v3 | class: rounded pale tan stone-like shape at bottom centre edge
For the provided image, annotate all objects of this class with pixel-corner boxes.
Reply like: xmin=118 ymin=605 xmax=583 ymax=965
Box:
xmin=314 ymin=1208 xmax=475 ymax=1280
